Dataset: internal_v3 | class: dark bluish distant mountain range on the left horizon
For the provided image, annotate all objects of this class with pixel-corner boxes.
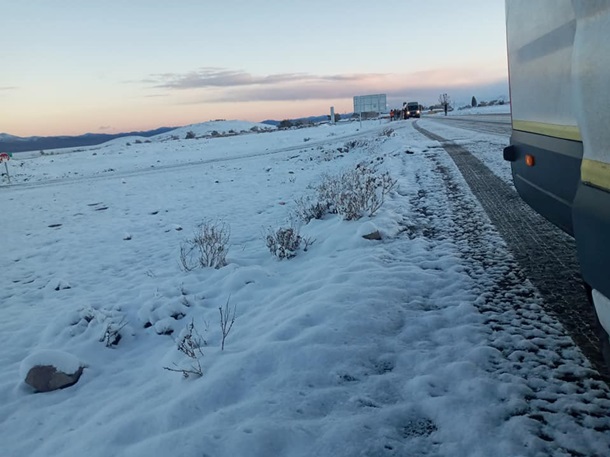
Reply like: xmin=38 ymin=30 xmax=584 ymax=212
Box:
xmin=0 ymin=127 xmax=176 ymax=152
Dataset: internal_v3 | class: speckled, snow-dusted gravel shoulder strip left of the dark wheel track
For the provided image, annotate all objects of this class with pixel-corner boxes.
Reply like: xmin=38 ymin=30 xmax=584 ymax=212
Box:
xmin=413 ymin=123 xmax=610 ymax=456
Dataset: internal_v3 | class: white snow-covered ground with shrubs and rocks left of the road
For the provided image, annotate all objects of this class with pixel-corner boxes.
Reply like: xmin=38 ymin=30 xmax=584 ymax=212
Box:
xmin=0 ymin=119 xmax=610 ymax=457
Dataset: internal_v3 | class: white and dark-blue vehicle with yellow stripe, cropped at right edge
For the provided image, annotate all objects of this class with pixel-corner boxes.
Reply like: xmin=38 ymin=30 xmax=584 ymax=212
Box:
xmin=504 ymin=0 xmax=610 ymax=362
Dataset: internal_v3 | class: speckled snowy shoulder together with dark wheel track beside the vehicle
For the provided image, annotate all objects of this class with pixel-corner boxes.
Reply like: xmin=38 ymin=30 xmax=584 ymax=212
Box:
xmin=402 ymin=119 xmax=610 ymax=456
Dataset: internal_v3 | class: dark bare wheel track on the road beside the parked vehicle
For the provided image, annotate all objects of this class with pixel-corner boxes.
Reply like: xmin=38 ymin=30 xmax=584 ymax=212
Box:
xmin=414 ymin=119 xmax=610 ymax=382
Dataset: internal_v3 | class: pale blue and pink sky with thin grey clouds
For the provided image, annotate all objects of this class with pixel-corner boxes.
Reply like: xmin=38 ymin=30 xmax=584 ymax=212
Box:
xmin=0 ymin=0 xmax=508 ymax=136
